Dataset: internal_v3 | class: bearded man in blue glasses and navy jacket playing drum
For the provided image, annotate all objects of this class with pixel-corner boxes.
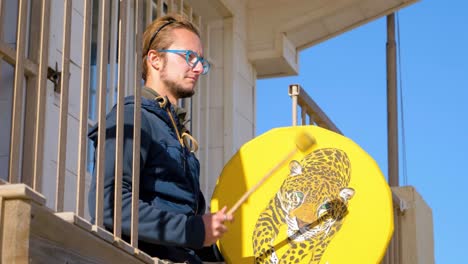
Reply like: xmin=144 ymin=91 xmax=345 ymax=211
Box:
xmin=89 ymin=15 xmax=233 ymax=263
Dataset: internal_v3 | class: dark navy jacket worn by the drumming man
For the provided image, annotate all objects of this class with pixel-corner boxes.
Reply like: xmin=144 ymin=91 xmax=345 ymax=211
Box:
xmin=89 ymin=92 xmax=206 ymax=263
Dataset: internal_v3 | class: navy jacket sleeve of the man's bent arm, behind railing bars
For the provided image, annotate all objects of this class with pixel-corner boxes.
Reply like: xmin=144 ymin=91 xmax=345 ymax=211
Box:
xmin=99 ymin=105 xmax=205 ymax=249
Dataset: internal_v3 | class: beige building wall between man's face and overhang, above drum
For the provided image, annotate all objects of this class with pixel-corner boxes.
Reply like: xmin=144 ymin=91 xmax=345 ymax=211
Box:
xmin=187 ymin=1 xmax=256 ymax=201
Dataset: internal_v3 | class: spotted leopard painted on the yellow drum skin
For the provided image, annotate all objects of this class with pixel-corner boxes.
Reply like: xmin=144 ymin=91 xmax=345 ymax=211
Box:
xmin=252 ymin=148 xmax=354 ymax=263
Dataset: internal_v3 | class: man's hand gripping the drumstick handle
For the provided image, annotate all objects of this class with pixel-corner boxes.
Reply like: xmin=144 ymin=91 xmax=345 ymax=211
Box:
xmin=202 ymin=206 xmax=234 ymax=247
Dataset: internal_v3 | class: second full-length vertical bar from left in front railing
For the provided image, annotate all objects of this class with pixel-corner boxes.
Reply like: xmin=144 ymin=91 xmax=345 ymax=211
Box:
xmin=32 ymin=0 xmax=50 ymax=192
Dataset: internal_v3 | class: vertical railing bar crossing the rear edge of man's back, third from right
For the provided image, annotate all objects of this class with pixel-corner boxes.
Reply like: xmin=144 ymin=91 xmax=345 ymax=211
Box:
xmin=95 ymin=0 xmax=109 ymax=227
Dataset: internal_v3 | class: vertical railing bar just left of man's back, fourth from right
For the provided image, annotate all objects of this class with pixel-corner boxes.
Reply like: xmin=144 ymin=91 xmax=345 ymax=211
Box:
xmin=75 ymin=0 xmax=92 ymax=217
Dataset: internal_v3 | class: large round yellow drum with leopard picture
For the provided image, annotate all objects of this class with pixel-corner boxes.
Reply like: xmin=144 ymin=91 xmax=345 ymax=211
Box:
xmin=211 ymin=126 xmax=393 ymax=264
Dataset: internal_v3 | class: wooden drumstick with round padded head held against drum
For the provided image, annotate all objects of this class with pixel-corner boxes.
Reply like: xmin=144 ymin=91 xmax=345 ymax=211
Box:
xmin=226 ymin=133 xmax=316 ymax=215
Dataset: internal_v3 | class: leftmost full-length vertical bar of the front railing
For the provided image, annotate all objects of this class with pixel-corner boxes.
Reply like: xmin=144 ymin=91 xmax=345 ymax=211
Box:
xmin=9 ymin=0 xmax=28 ymax=183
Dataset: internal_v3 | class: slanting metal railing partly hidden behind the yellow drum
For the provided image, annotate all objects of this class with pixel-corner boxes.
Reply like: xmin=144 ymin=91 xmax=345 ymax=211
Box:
xmin=288 ymin=84 xmax=406 ymax=264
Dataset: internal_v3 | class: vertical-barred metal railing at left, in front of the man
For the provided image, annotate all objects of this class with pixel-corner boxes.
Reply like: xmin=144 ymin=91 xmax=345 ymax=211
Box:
xmin=0 ymin=0 xmax=201 ymax=263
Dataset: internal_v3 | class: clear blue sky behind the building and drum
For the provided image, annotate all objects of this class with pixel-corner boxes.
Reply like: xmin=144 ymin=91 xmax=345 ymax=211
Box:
xmin=256 ymin=0 xmax=468 ymax=263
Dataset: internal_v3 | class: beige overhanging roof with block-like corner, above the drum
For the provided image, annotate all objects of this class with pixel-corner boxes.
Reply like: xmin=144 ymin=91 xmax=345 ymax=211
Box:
xmin=247 ymin=0 xmax=418 ymax=78
